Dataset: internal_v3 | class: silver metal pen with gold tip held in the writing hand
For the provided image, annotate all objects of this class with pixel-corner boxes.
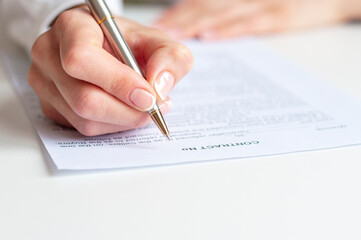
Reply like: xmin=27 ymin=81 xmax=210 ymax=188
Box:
xmin=85 ymin=0 xmax=170 ymax=139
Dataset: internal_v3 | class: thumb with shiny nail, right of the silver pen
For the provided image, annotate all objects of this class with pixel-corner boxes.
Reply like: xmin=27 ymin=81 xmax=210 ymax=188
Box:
xmin=116 ymin=18 xmax=193 ymax=100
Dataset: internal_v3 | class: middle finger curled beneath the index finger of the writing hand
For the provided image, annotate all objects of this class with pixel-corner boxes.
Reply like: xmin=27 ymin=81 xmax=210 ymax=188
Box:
xmin=29 ymin=34 xmax=152 ymax=127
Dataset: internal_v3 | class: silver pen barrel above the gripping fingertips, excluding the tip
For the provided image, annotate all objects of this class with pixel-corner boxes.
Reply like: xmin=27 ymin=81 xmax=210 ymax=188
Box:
xmin=85 ymin=0 xmax=144 ymax=77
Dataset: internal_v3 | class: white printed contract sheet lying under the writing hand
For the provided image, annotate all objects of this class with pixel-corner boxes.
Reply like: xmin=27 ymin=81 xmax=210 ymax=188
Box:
xmin=4 ymin=39 xmax=361 ymax=170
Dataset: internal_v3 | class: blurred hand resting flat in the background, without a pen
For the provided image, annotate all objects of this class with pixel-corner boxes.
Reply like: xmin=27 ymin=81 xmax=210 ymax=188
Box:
xmin=155 ymin=0 xmax=361 ymax=40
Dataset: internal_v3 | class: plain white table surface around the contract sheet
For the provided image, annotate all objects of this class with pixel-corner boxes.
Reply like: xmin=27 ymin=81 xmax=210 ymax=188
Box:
xmin=0 ymin=4 xmax=361 ymax=240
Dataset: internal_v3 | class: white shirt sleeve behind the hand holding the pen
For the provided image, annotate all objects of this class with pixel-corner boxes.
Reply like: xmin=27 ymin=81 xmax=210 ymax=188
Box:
xmin=2 ymin=0 xmax=122 ymax=53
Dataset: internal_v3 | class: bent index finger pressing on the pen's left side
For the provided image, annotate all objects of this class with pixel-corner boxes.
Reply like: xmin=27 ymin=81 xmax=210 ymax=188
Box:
xmin=54 ymin=9 xmax=156 ymax=111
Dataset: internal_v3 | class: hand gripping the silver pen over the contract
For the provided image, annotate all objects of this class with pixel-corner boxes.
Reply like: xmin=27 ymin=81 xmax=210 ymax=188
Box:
xmin=28 ymin=7 xmax=193 ymax=136
